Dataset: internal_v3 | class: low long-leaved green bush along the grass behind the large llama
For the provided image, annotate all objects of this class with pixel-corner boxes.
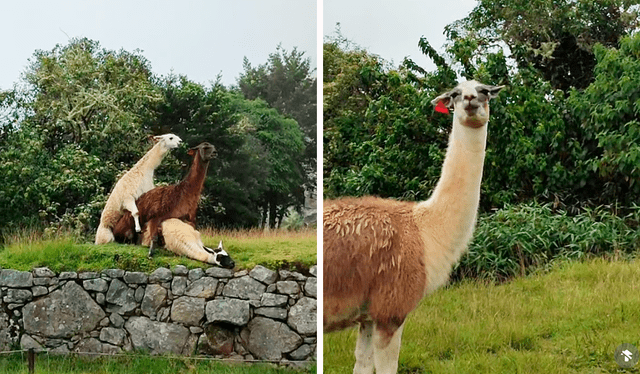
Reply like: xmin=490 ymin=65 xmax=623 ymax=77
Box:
xmin=452 ymin=203 xmax=640 ymax=281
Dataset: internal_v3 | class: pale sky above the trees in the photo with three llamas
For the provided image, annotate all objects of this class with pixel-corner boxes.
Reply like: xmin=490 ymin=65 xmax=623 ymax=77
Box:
xmin=0 ymin=0 xmax=317 ymax=89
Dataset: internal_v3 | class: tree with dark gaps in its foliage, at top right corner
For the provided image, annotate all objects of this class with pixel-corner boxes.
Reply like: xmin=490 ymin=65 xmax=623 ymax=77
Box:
xmin=445 ymin=0 xmax=639 ymax=93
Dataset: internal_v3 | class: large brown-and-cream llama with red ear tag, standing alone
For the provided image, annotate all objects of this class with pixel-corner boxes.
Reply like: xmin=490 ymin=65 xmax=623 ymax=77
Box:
xmin=323 ymin=81 xmax=503 ymax=374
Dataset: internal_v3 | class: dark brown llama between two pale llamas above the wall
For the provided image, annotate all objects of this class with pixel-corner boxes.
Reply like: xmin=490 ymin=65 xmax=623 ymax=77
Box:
xmin=113 ymin=142 xmax=216 ymax=256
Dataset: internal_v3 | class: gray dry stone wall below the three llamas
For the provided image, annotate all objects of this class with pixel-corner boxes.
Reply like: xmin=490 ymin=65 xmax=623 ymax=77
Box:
xmin=0 ymin=265 xmax=317 ymax=362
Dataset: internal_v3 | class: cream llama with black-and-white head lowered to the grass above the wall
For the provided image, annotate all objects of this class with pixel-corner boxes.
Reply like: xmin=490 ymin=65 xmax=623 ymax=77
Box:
xmin=159 ymin=218 xmax=236 ymax=269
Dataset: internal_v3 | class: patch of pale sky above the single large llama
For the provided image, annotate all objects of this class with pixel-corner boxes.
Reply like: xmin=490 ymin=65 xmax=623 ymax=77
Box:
xmin=323 ymin=0 xmax=477 ymax=70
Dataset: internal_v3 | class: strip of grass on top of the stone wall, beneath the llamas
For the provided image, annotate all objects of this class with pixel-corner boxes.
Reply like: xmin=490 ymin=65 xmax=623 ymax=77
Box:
xmin=0 ymin=229 xmax=317 ymax=272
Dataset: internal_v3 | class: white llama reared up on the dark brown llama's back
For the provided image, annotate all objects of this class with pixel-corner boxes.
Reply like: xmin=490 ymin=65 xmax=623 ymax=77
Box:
xmin=95 ymin=134 xmax=182 ymax=244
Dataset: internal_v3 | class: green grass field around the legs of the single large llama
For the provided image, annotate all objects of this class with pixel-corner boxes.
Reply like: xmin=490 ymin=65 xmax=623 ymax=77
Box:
xmin=324 ymin=259 xmax=640 ymax=374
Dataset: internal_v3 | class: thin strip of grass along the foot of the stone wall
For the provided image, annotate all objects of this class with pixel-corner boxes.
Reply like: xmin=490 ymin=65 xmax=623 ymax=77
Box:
xmin=0 ymin=353 xmax=316 ymax=374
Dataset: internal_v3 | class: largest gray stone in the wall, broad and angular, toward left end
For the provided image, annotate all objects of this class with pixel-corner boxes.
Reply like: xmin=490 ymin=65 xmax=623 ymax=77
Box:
xmin=22 ymin=282 xmax=105 ymax=338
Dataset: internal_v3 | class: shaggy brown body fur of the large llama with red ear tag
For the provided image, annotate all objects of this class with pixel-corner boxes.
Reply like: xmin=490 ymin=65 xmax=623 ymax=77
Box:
xmin=323 ymin=197 xmax=426 ymax=331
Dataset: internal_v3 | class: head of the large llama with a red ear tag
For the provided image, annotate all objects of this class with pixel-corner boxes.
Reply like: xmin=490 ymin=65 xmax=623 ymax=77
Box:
xmin=431 ymin=80 xmax=504 ymax=128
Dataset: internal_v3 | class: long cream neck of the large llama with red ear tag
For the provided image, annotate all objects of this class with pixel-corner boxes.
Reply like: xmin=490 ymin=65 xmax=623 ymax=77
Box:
xmin=415 ymin=116 xmax=487 ymax=263
